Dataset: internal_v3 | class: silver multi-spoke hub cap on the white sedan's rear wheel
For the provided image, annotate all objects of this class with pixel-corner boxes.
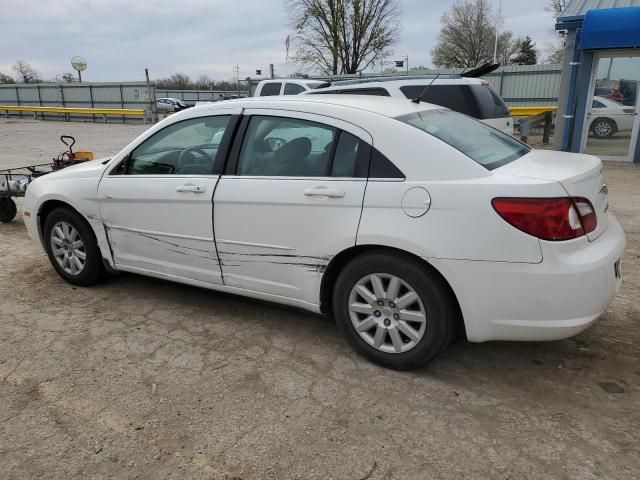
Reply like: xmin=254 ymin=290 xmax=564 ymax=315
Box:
xmin=349 ymin=273 xmax=427 ymax=353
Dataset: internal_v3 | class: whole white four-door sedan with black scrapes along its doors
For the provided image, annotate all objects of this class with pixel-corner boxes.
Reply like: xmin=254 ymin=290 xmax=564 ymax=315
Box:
xmin=24 ymin=95 xmax=625 ymax=369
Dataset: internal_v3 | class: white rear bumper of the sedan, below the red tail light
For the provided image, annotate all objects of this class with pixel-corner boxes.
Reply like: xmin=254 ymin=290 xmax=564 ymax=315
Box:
xmin=428 ymin=216 xmax=625 ymax=342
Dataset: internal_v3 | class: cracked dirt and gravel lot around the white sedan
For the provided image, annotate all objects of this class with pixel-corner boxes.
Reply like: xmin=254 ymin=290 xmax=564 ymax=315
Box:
xmin=0 ymin=120 xmax=640 ymax=480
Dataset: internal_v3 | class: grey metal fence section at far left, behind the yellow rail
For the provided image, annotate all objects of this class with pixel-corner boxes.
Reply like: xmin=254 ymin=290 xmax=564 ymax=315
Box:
xmin=0 ymin=82 xmax=156 ymax=122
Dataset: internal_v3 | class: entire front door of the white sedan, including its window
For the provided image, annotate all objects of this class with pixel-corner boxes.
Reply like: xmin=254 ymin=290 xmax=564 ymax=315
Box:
xmin=98 ymin=110 xmax=240 ymax=284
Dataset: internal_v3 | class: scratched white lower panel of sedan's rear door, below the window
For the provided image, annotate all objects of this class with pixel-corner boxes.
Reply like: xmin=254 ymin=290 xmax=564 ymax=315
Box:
xmin=214 ymin=176 xmax=366 ymax=303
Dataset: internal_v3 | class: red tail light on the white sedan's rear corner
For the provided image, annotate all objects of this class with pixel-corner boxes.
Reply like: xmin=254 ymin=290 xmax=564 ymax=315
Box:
xmin=491 ymin=197 xmax=598 ymax=240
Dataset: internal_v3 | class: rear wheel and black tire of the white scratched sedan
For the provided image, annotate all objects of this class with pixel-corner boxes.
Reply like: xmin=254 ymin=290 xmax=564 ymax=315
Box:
xmin=333 ymin=252 xmax=458 ymax=370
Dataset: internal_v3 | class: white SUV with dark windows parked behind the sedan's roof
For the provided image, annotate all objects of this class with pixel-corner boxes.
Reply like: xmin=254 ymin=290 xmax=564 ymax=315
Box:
xmin=305 ymin=75 xmax=513 ymax=135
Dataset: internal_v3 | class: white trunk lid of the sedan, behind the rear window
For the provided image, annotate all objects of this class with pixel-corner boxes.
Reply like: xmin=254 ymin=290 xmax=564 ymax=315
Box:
xmin=494 ymin=150 xmax=609 ymax=241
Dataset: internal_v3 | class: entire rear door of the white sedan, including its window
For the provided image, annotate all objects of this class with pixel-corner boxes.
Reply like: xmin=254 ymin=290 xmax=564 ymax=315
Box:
xmin=214 ymin=109 xmax=371 ymax=304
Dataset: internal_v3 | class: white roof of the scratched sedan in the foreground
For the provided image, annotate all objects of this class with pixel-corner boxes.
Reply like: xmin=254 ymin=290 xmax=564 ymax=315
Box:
xmin=198 ymin=94 xmax=443 ymax=118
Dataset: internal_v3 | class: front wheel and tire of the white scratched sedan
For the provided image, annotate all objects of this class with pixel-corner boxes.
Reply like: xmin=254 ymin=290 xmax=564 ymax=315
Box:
xmin=43 ymin=207 xmax=104 ymax=287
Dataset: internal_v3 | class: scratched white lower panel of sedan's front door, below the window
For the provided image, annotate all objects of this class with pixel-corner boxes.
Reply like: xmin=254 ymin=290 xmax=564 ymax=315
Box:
xmin=99 ymin=175 xmax=222 ymax=283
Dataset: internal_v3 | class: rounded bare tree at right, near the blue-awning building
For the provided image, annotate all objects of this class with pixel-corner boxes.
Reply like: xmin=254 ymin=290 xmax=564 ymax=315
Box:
xmin=431 ymin=0 xmax=495 ymax=68
